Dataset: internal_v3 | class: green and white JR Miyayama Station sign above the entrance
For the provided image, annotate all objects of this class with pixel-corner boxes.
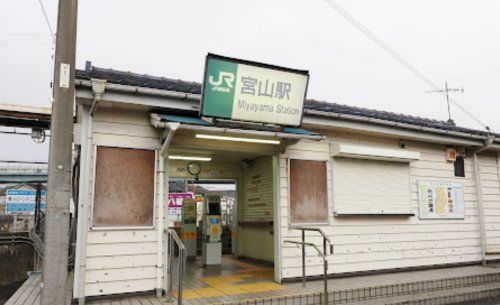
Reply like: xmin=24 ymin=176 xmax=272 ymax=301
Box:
xmin=201 ymin=54 xmax=309 ymax=126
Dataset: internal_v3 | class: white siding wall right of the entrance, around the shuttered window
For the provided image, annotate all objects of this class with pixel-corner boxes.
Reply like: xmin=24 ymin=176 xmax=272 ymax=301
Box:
xmin=280 ymin=133 xmax=500 ymax=278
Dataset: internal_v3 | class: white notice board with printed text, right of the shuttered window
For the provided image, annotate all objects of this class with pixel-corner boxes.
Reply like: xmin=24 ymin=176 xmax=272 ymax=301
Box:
xmin=418 ymin=181 xmax=465 ymax=219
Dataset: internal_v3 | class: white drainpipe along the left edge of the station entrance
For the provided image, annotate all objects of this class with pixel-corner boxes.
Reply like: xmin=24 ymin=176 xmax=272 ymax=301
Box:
xmin=156 ymin=123 xmax=180 ymax=297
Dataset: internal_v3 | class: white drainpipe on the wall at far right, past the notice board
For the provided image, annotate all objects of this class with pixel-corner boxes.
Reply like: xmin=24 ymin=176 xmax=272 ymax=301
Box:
xmin=473 ymin=135 xmax=495 ymax=265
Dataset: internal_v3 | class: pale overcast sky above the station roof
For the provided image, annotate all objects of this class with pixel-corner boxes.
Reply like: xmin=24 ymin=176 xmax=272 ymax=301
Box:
xmin=0 ymin=0 xmax=500 ymax=160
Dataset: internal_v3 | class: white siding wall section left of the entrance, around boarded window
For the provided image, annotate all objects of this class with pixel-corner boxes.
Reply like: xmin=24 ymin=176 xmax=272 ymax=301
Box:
xmin=84 ymin=108 xmax=159 ymax=296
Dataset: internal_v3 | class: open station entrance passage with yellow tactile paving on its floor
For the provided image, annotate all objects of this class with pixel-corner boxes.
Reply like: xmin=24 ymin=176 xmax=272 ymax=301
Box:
xmin=167 ymin=153 xmax=283 ymax=302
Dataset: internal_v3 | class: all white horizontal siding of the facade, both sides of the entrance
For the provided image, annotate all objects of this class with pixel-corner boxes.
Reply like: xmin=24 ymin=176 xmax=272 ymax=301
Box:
xmin=77 ymin=107 xmax=500 ymax=286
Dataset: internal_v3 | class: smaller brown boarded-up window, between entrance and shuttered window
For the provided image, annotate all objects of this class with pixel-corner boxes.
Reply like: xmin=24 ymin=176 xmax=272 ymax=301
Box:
xmin=290 ymin=159 xmax=328 ymax=223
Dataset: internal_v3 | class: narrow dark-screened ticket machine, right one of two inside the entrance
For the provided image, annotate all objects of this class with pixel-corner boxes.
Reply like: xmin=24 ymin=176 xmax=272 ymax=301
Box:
xmin=201 ymin=195 xmax=222 ymax=265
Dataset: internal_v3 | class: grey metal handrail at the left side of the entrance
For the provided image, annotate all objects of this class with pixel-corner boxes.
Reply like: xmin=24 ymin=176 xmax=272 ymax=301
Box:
xmin=165 ymin=229 xmax=186 ymax=305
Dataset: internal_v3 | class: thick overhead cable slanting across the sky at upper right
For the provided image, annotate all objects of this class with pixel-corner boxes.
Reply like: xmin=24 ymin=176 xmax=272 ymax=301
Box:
xmin=325 ymin=0 xmax=490 ymax=131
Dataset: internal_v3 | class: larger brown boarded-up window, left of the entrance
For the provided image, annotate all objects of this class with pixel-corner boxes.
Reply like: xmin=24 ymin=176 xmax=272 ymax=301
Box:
xmin=92 ymin=146 xmax=155 ymax=227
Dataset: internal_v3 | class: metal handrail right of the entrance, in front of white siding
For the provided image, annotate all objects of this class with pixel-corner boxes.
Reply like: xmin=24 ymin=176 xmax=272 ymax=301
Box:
xmin=283 ymin=226 xmax=333 ymax=305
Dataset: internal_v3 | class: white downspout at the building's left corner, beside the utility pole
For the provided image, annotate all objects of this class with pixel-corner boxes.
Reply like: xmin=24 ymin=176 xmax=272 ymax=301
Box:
xmin=74 ymin=79 xmax=106 ymax=305
